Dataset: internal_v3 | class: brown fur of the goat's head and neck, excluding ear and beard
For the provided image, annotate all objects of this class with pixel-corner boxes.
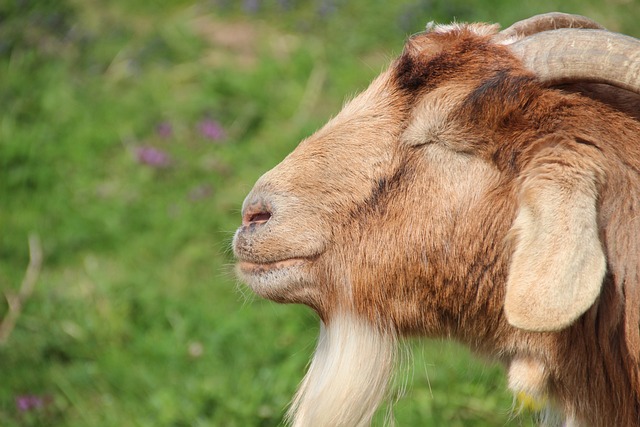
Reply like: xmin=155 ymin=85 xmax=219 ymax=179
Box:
xmin=235 ymin=26 xmax=640 ymax=426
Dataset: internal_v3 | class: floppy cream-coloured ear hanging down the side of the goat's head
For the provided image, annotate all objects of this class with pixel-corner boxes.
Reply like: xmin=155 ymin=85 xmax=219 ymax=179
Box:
xmin=504 ymin=137 xmax=606 ymax=331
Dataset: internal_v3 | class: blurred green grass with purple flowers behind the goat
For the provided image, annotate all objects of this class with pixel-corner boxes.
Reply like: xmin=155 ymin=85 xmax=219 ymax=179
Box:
xmin=0 ymin=0 xmax=640 ymax=426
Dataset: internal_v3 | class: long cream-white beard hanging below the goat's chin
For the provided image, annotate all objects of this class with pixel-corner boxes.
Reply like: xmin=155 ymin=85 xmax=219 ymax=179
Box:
xmin=288 ymin=314 xmax=397 ymax=427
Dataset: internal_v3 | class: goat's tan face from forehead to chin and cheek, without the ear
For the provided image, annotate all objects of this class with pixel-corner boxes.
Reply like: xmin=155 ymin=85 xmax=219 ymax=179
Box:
xmin=234 ymin=27 xmax=524 ymax=333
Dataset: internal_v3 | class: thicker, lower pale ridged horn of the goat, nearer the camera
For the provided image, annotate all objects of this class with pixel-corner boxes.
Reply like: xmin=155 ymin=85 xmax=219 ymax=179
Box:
xmin=509 ymin=29 xmax=640 ymax=94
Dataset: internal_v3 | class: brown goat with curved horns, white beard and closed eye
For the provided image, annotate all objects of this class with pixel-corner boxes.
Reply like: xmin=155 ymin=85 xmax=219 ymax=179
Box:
xmin=233 ymin=13 xmax=640 ymax=426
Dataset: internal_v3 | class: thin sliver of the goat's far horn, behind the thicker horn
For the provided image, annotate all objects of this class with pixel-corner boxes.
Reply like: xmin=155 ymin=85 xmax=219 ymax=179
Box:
xmin=496 ymin=12 xmax=605 ymax=44
